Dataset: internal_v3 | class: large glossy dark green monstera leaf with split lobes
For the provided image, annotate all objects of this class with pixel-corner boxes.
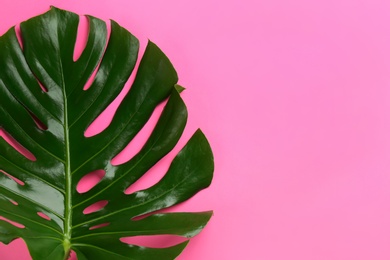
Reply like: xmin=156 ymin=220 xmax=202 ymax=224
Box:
xmin=0 ymin=8 xmax=213 ymax=260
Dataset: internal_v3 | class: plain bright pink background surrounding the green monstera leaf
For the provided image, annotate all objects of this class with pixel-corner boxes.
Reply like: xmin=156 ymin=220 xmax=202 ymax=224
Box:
xmin=0 ymin=0 xmax=390 ymax=260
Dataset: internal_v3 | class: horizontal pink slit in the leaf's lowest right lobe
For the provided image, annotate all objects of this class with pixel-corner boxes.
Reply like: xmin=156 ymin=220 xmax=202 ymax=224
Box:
xmin=120 ymin=235 xmax=187 ymax=248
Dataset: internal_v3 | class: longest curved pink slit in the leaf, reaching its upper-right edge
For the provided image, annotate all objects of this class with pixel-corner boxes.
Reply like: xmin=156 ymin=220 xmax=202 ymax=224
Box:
xmin=84 ymin=36 xmax=147 ymax=137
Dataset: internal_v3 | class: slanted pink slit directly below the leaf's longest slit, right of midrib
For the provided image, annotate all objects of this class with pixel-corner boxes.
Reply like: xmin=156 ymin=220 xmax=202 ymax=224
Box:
xmin=111 ymin=101 xmax=167 ymax=166
